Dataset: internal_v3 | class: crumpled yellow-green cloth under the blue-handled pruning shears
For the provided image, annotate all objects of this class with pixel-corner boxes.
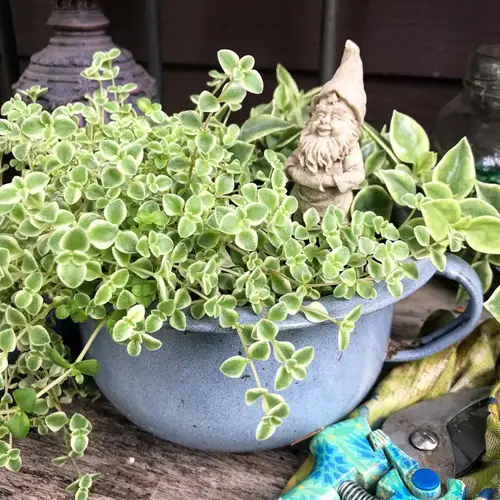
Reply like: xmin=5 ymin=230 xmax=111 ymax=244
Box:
xmin=285 ymin=319 xmax=500 ymax=500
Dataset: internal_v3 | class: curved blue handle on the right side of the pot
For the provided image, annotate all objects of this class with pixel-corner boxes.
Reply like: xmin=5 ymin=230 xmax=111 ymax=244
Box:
xmin=386 ymin=254 xmax=483 ymax=363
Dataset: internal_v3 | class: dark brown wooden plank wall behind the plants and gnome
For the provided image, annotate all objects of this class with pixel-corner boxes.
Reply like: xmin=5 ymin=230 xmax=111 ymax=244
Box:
xmin=12 ymin=0 xmax=500 ymax=128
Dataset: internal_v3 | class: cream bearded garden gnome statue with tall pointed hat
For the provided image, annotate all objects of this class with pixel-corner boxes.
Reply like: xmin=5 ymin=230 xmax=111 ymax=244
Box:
xmin=286 ymin=40 xmax=366 ymax=217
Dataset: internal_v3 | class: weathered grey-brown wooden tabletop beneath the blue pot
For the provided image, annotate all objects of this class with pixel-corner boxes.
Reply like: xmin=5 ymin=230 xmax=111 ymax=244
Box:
xmin=0 ymin=282 xmax=482 ymax=500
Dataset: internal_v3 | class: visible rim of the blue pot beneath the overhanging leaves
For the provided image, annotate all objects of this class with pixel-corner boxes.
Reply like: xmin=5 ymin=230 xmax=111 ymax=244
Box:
xmin=178 ymin=259 xmax=436 ymax=333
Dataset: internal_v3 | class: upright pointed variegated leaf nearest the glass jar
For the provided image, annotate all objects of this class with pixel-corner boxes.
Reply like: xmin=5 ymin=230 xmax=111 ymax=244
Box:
xmin=432 ymin=137 xmax=476 ymax=198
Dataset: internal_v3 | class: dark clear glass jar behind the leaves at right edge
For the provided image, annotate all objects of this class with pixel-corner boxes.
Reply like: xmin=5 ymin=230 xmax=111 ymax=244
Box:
xmin=432 ymin=45 xmax=500 ymax=184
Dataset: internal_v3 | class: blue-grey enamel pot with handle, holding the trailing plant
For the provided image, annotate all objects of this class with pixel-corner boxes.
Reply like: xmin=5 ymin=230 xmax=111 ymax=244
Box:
xmin=81 ymin=255 xmax=482 ymax=452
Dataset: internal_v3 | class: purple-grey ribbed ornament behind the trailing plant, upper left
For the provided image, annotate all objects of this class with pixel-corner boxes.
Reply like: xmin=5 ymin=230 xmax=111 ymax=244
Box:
xmin=13 ymin=0 xmax=156 ymax=110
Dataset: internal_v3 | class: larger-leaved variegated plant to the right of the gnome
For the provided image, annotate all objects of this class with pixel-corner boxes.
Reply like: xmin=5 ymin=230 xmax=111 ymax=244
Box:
xmin=360 ymin=112 xmax=500 ymax=310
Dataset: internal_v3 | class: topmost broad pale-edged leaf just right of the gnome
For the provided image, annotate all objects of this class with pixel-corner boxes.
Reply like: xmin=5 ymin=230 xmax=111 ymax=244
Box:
xmin=389 ymin=111 xmax=429 ymax=164
